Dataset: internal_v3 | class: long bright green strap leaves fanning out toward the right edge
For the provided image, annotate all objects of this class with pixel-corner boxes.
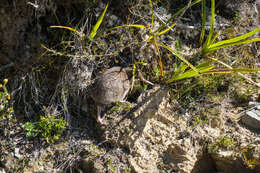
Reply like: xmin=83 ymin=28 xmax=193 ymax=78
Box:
xmin=167 ymin=0 xmax=260 ymax=83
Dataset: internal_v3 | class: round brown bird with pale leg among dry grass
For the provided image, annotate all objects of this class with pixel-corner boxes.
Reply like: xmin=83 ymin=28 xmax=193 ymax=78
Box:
xmin=90 ymin=67 xmax=153 ymax=124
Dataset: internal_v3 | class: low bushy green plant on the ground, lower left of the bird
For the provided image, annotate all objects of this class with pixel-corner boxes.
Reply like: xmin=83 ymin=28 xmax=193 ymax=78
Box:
xmin=24 ymin=108 xmax=67 ymax=143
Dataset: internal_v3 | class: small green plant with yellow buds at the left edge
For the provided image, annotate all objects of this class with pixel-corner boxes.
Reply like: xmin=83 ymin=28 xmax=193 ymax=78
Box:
xmin=0 ymin=79 xmax=14 ymax=119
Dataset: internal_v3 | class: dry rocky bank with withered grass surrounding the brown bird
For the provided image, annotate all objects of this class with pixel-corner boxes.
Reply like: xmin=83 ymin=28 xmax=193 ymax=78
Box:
xmin=0 ymin=0 xmax=260 ymax=173
